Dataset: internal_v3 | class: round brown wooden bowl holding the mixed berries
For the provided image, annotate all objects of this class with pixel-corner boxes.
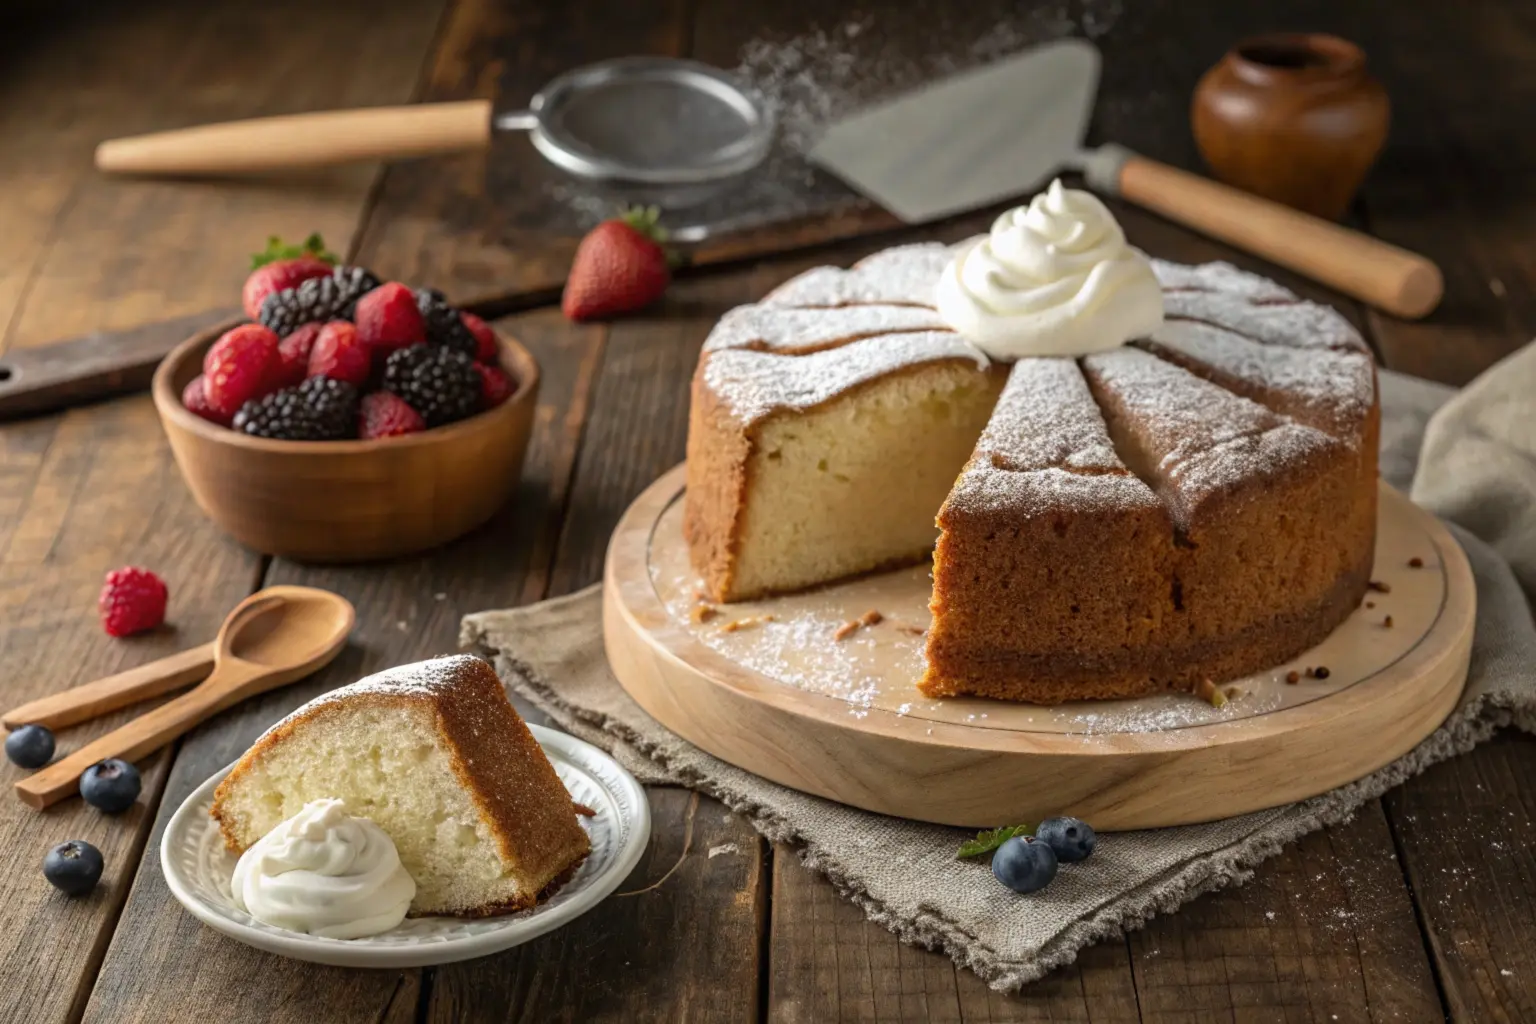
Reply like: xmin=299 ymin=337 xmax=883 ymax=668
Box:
xmin=152 ymin=321 xmax=539 ymax=562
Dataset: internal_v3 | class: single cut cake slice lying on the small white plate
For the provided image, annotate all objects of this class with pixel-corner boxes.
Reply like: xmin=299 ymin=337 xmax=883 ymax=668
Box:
xmin=210 ymin=656 xmax=591 ymax=917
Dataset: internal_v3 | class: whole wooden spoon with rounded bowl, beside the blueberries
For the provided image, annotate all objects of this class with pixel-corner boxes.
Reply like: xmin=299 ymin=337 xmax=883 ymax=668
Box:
xmin=15 ymin=586 xmax=356 ymax=811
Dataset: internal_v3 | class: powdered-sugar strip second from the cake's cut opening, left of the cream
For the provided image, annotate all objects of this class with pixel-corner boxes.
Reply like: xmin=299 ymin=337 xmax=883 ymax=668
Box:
xmin=703 ymin=304 xmax=949 ymax=356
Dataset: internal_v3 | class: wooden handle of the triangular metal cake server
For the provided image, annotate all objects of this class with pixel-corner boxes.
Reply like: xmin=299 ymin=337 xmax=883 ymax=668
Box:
xmin=1084 ymin=146 xmax=1445 ymax=319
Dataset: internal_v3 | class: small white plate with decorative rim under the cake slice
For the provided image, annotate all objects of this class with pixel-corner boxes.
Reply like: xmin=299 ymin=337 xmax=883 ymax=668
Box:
xmin=160 ymin=726 xmax=651 ymax=967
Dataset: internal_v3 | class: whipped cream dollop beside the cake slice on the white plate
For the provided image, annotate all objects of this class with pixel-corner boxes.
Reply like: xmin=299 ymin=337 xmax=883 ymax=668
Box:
xmin=233 ymin=800 xmax=416 ymax=938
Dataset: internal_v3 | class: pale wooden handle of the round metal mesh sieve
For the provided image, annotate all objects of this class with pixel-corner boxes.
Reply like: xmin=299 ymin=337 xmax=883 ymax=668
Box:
xmin=95 ymin=100 xmax=492 ymax=175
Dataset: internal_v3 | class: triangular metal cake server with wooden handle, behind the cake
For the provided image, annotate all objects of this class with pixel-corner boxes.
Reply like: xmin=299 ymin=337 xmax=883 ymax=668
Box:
xmin=809 ymin=40 xmax=1444 ymax=318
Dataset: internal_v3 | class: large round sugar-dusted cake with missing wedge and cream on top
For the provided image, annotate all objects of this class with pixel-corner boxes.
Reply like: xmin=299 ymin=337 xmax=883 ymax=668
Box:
xmin=685 ymin=184 xmax=1379 ymax=703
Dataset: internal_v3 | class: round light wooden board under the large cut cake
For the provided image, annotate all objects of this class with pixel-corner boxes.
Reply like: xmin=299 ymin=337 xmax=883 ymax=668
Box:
xmin=604 ymin=467 xmax=1476 ymax=831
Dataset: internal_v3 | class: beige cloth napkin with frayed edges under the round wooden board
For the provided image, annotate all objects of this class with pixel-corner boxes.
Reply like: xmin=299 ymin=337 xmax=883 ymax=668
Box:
xmin=462 ymin=345 xmax=1536 ymax=989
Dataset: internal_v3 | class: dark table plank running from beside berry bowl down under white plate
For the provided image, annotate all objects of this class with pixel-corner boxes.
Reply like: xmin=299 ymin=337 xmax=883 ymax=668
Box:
xmin=86 ymin=303 xmax=598 ymax=1024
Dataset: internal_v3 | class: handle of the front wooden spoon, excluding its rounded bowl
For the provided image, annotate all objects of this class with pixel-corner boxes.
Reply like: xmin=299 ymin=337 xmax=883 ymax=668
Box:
xmin=15 ymin=660 xmax=263 ymax=811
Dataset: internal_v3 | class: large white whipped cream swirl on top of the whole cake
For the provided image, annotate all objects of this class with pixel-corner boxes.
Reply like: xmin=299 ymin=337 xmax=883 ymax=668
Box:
xmin=938 ymin=181 xmax=1163 ymax=361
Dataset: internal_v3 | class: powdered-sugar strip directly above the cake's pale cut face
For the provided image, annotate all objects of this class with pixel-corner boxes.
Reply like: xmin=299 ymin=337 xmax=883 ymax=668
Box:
xmin=703 ymin=332 xmax=991 ymax=422
